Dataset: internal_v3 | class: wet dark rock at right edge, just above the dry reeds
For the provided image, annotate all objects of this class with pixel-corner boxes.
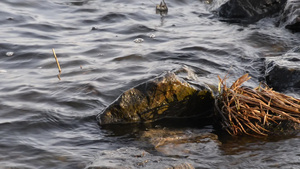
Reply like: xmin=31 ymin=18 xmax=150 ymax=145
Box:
xmin=266 ymin=52 xmax=300 ymax=91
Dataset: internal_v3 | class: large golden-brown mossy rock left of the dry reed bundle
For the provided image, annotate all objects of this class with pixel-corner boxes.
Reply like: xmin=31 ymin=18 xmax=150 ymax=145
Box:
xmin=97 ymin=72 xmax=214 ymax=125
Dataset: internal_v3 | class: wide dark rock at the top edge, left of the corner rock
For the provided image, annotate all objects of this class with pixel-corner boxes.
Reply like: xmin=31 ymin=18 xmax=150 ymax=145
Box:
xmin=218 ymin=0 xmax=287 ymax=24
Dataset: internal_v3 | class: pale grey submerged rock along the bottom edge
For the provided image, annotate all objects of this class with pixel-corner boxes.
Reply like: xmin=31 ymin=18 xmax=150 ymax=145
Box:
xmin=86 ymin=147 xmax=194 ymax=169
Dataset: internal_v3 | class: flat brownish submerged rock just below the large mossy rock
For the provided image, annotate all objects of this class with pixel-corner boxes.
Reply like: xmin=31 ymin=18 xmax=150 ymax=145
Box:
xmin=140 ymin=128 xmax=221 ymax=157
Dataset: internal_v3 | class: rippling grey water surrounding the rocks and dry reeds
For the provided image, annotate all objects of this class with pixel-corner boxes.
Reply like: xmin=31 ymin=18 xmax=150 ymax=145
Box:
xmin=0 ymin=0 xmax=300 ymax=168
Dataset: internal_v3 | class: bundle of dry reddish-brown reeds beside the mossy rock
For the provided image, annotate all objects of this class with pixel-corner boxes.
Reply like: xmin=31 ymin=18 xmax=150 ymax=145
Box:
xmin=216 ymin=74 xmax=300 ymax=136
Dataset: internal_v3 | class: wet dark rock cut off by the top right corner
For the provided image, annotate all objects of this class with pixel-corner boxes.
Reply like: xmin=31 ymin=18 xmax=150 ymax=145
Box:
xmin=280 ymin=0 xmax=300 ymax=32
